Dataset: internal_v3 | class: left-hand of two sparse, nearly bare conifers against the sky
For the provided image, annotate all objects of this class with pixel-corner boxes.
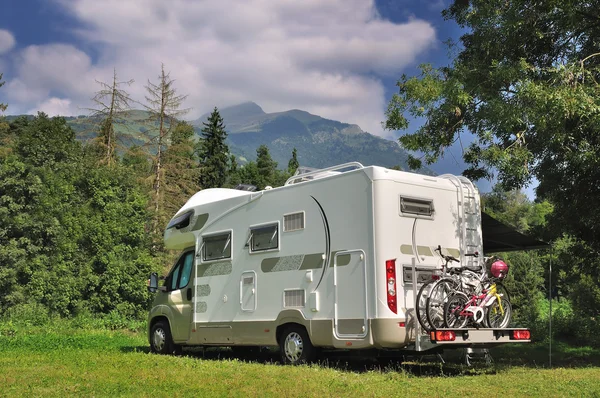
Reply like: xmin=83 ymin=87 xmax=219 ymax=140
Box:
xmin=89 ymin=69 xmax=133 ymax=165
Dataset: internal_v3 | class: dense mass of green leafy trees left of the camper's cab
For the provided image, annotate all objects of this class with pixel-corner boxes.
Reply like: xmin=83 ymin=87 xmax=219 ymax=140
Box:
xmin=0 ymin=114 xmax=158 ymax=317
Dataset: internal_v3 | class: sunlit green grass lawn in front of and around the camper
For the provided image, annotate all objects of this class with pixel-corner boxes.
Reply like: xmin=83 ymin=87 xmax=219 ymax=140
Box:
xmin=0 ymin=328 xmax=600 ymax=397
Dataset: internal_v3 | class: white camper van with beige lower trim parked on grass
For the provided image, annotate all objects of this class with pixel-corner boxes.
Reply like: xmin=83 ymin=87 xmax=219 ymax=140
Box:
xmin=148 ymin=163 xmax=528 ymax=363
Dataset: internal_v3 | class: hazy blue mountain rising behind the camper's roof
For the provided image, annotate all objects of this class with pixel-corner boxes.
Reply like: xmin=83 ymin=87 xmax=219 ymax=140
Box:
xmin=192 ymin=102 xmax=434 ymax=174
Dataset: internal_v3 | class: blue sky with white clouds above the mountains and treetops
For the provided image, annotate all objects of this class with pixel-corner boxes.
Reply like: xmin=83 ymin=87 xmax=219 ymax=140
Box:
xmin=0 ymin=0 xmax=510 ymax=190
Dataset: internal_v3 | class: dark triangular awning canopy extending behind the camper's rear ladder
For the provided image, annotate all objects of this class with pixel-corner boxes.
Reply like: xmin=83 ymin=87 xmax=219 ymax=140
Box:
xmin=481 ymin=212 xmax=550 ymax=253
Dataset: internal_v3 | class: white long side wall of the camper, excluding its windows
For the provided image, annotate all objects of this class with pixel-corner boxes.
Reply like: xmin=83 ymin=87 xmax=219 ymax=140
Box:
xmin=171 ymin=170 xmax=374 ymax=346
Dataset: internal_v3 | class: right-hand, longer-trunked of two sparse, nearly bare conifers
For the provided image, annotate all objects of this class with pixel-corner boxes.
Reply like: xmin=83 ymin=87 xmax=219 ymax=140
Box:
xmin=146 ymin=64 xmax=189 ymax=233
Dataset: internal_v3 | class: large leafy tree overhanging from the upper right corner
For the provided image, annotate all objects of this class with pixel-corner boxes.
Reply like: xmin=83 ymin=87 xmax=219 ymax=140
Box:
xmin=385 ymin=0 xmax=600 ymax=251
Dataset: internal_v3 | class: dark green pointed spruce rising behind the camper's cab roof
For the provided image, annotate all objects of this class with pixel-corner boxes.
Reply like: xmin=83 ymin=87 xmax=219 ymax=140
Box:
xmin=198 ymin=107 xmax=229 ymax=189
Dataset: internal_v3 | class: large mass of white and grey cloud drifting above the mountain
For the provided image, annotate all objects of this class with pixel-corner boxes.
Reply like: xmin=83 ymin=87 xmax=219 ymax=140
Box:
xmin=4 ymin=0 xmax=435 ymax=135
